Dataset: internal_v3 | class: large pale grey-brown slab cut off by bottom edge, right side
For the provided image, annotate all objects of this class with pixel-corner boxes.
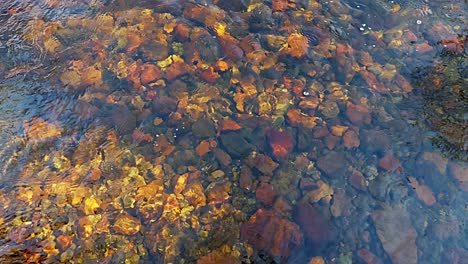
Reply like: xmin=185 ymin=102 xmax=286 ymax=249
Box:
xmin=372 ymin=207 xmax=418 ymax=264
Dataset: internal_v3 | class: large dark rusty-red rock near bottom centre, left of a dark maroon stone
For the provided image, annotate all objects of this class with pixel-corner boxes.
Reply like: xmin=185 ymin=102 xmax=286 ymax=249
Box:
xmin=241 ymin=209 xmax=304 ymax=257
